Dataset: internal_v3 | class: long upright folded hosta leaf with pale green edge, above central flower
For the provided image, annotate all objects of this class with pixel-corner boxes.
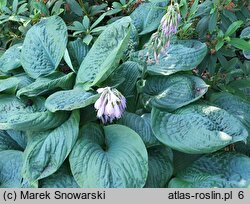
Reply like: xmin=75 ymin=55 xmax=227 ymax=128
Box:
xmin=76 ymin=17 xmax=131 ymax=89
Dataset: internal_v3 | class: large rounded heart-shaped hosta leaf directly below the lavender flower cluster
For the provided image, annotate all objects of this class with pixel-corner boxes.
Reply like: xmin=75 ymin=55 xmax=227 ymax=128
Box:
xmin=69 ymin=123 xmax=148 ymax=188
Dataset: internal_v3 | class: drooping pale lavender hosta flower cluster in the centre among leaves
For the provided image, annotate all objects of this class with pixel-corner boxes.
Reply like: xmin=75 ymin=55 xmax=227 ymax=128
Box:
xmin=94 ymin=87 xmax=126 ymax=124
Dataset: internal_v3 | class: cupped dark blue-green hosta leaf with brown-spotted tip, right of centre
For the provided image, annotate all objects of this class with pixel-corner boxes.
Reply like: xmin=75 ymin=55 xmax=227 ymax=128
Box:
xmin=143 ymin=75 xmax=208 ymax=111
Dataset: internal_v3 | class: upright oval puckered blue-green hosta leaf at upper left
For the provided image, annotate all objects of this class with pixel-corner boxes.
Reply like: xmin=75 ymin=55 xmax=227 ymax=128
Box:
xmin=21 ymin=16 xmax=68 ymax=79
